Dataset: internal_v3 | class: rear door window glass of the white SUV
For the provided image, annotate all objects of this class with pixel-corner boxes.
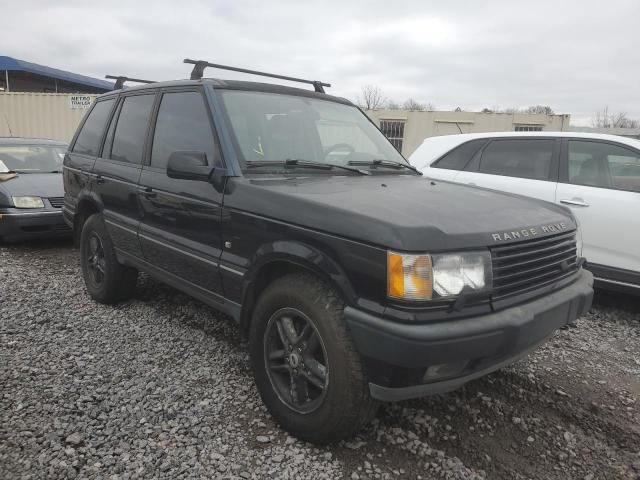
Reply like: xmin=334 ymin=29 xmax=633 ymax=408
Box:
xmin=478 ymin=139 xmax=555 ymax=180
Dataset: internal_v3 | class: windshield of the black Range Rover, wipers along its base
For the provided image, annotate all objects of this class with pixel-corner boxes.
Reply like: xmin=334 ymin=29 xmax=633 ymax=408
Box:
xmin=222 ymin=90 xmax=408 ymax=174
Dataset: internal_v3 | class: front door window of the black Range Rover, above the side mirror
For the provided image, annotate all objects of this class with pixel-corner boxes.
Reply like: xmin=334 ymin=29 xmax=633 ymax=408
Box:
xmin=151 ymin=92 xmax=220 ymax=168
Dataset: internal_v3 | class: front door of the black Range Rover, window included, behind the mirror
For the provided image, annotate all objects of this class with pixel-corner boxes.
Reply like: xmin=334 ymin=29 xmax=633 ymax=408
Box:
xmin=139 ymin=89 xmax=223 ymax=293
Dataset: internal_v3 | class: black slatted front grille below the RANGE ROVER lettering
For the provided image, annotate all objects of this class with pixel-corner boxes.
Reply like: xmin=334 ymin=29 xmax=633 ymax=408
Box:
xmin=491 ymin=232 xmax=578 ymax=300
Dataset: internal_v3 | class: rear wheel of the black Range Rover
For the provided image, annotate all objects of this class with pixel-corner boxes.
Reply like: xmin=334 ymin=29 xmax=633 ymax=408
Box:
xmin=80 ymin=213 xmax=138 ymax=304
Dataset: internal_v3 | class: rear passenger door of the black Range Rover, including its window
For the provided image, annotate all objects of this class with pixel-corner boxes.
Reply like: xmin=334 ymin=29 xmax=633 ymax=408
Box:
xmin=93 ymin=92 xmax=156 ymax=258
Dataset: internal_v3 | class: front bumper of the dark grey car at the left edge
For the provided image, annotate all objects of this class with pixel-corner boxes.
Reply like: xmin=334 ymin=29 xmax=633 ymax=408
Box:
xmin=0 ymin=208 xmax=71 ymax=242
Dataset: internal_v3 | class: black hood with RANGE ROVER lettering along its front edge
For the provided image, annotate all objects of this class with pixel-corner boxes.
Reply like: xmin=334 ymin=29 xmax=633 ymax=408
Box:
xmin=225 ymin=175 xmax=576 ymax=251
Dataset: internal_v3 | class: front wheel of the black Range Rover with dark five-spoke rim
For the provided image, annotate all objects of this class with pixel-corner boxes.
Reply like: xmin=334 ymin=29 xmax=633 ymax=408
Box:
xmin=249 ymin=273 xmax=378 ymax=444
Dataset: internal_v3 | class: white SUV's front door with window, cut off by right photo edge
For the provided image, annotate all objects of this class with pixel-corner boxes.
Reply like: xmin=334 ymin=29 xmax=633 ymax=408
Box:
xmin=556 ymin=139 xmax=640 ymax=283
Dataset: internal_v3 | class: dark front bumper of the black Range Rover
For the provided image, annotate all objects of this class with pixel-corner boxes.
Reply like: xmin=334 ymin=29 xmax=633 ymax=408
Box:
xmin=345 ymin=270 xmax=593 ymax=401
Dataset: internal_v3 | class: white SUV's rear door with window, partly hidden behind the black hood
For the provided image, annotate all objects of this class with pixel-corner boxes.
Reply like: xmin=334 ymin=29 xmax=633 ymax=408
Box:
xmin=454 ymin=137 xmax=560 ymax=202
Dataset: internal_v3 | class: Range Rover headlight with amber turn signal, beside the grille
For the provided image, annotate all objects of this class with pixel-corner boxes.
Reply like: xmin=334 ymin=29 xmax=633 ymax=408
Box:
xmin=387 ymin=251 xmax=492 ymax=300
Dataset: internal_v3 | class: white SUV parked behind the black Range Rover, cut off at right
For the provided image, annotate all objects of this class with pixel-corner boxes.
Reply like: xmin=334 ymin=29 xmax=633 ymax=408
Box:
xmin=410 ymin=132 xmax=640 ymax=293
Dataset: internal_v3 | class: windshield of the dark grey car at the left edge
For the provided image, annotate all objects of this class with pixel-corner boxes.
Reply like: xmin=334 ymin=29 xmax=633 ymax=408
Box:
xmin=0 ymin=145 xmax=66 ymax=173
